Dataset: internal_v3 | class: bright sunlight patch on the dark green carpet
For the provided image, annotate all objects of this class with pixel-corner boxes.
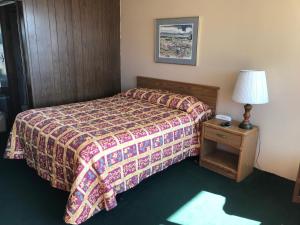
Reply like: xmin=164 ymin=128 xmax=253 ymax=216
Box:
xmin=167 ymin=191 xmax=261 ymax=225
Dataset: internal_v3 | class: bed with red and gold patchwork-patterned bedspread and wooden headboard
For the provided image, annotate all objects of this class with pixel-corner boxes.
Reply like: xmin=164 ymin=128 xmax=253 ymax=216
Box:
xmin=4 ymin=77 xmax=218 ymax=224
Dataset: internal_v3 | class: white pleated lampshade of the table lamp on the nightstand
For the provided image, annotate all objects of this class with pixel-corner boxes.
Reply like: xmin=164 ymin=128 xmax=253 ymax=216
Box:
xmin=232 ymin=70 xmax=269 ymax=104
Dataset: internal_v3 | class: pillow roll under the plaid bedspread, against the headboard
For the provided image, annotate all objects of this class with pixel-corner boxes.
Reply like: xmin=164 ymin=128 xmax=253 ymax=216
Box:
xmin=121 ymin=88 xmax=212 ymax=122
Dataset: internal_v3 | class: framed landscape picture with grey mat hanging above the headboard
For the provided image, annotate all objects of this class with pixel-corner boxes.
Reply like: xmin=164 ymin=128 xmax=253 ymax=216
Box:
xmin=155 ymin=17 xmax=199 ymax=66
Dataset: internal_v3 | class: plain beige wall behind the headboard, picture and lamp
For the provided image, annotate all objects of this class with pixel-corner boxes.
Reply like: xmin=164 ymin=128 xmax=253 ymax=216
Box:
xmin=121 ymin=0 xmax=300 ymax=179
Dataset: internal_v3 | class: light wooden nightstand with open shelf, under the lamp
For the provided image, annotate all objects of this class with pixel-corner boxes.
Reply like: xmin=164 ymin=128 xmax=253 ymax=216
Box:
xmin=200 ymin=119 xmax=258 ymax=182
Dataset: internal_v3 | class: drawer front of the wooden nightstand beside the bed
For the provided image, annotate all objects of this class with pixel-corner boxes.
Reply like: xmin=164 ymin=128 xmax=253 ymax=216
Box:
xmin=204 ymin=127 xmax=242 ymax=148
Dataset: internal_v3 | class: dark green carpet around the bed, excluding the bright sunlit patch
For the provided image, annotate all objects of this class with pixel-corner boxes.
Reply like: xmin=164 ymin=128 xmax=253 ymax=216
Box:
xmin=0 ymin=134 xmax=300 ymax=225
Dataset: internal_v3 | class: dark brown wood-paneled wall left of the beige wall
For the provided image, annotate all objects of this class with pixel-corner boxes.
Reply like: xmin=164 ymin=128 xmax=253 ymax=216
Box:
xmin=22 ymin=0 xmax=120 ymax=107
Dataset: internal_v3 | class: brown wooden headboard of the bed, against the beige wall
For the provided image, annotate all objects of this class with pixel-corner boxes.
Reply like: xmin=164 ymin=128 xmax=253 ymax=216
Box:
xmin=137 ymin=76 xmax=220 ymax=112
